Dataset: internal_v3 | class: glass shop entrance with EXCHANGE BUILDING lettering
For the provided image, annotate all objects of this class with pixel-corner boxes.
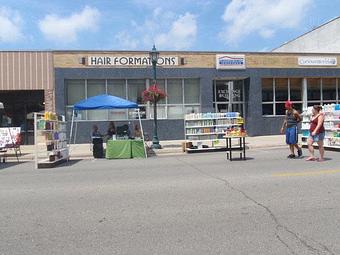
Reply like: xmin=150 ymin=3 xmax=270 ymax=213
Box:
xmin=213 ymin=79 xmax=245 ymax=117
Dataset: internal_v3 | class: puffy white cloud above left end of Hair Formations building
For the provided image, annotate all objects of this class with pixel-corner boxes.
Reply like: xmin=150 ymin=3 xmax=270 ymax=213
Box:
xmin=39 ymin=6 xmax=100 ymax=43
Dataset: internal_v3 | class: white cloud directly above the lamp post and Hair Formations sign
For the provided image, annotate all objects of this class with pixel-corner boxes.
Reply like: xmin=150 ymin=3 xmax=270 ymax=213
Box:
xmin=115 ymin=8 xmax=197 ymax=50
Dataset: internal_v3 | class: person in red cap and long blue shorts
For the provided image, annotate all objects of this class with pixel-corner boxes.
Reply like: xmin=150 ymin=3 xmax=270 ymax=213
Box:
xmin=281 ymin=101 xmax=302 ymax=158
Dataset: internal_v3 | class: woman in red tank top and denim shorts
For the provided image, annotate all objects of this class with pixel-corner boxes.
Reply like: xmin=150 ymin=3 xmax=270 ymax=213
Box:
xmin=306 ymin=105 xmax=325 ymax=162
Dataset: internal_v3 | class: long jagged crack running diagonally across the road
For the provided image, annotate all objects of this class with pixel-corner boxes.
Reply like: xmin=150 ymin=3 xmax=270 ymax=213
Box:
xmin=177 ymin=158 xmax=335 ymax=255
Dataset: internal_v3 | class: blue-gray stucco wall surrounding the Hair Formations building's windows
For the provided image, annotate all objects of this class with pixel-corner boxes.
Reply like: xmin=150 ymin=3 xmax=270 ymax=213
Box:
xmin=55 ymin=68 xmax=340 ymax=143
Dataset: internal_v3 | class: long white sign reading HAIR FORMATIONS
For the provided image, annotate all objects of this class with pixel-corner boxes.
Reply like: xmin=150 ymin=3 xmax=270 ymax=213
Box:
xmin=87 ymin=55 xmax=178 ymax=66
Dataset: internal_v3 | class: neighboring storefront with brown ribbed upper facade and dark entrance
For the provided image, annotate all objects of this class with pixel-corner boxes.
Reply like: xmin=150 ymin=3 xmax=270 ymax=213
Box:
xmin=0 ymin=51 xmax=54 ymax=144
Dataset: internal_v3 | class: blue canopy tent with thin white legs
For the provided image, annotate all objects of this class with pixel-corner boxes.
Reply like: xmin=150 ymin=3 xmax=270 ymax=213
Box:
xmin=70 ymin=94 xmax=147 ymax=155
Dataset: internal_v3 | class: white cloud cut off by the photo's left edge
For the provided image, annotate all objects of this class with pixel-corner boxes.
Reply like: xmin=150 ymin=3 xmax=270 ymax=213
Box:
xmin=0 ymin=7 xmax=24 ymax=42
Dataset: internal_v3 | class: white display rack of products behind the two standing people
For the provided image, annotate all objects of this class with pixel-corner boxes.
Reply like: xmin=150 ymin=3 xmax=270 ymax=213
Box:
xmin=301 ymin=104 xmax=340 ymax=150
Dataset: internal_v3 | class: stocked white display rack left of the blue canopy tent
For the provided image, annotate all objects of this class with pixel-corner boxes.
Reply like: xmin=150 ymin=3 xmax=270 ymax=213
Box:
xmin=34 ymin=112 xmax=69 ymax=169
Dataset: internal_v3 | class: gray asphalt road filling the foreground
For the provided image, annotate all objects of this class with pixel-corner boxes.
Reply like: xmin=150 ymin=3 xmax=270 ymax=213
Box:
xmin=0 ymin=149 xmax=340 ymax=255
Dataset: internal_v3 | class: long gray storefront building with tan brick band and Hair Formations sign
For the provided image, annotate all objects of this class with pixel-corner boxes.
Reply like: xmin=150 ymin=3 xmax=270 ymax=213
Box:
xmin=1 ymin=51 xmax=340 ymax=143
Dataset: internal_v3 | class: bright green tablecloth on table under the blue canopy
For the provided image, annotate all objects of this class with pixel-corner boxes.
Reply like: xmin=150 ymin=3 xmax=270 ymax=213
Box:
xmin=106 ymin=140 xmax=145 ymax=159
